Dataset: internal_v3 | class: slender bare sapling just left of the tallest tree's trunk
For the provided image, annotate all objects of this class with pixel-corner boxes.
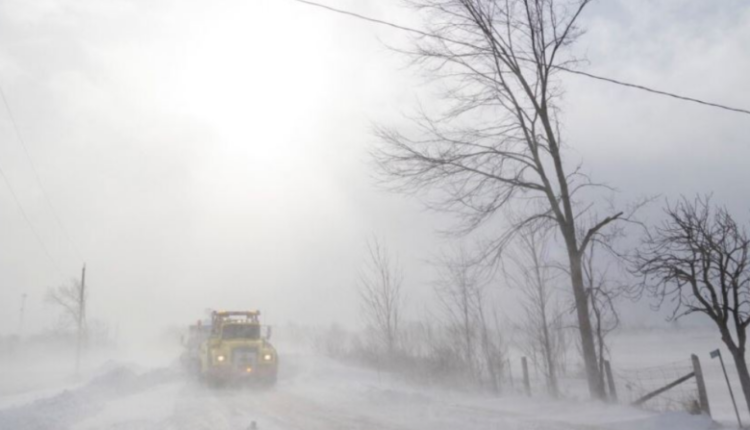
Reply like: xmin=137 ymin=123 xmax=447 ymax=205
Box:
xmin=506 ymin=226 xmax=566 ymax=397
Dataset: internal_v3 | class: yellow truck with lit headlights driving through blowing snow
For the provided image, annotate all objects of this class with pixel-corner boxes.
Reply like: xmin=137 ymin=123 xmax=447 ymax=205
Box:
xmin=200 ymin=311 xmax=279 ymax=385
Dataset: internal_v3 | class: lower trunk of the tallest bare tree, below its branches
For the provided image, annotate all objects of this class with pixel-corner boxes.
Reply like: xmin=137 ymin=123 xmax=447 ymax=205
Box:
xmin=568 ymin=249 xmax=605 ymax=400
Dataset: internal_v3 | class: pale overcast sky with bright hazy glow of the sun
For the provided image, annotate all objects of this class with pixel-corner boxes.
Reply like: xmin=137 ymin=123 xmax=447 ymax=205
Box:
xmin=0 ymin=0 xmax=750 ymax=342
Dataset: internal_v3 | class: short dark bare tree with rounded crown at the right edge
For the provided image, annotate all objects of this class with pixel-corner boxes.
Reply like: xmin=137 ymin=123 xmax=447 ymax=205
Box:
xmin=635 ymin=198 xmax=750 ymax=410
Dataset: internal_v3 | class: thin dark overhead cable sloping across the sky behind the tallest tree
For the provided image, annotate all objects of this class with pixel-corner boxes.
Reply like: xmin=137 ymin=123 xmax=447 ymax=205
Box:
xmin=291 ymin=0 xmax=750 ymax=115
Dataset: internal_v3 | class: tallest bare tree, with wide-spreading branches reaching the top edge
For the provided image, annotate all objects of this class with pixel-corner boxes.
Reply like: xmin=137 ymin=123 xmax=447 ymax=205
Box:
xmin=373 ymin=0 xmax=622 ymax=398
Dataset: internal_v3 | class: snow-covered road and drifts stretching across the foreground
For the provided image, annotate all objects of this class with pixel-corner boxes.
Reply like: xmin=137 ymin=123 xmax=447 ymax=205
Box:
xmin=0 ymin=333 xmax=732 ymax=430
